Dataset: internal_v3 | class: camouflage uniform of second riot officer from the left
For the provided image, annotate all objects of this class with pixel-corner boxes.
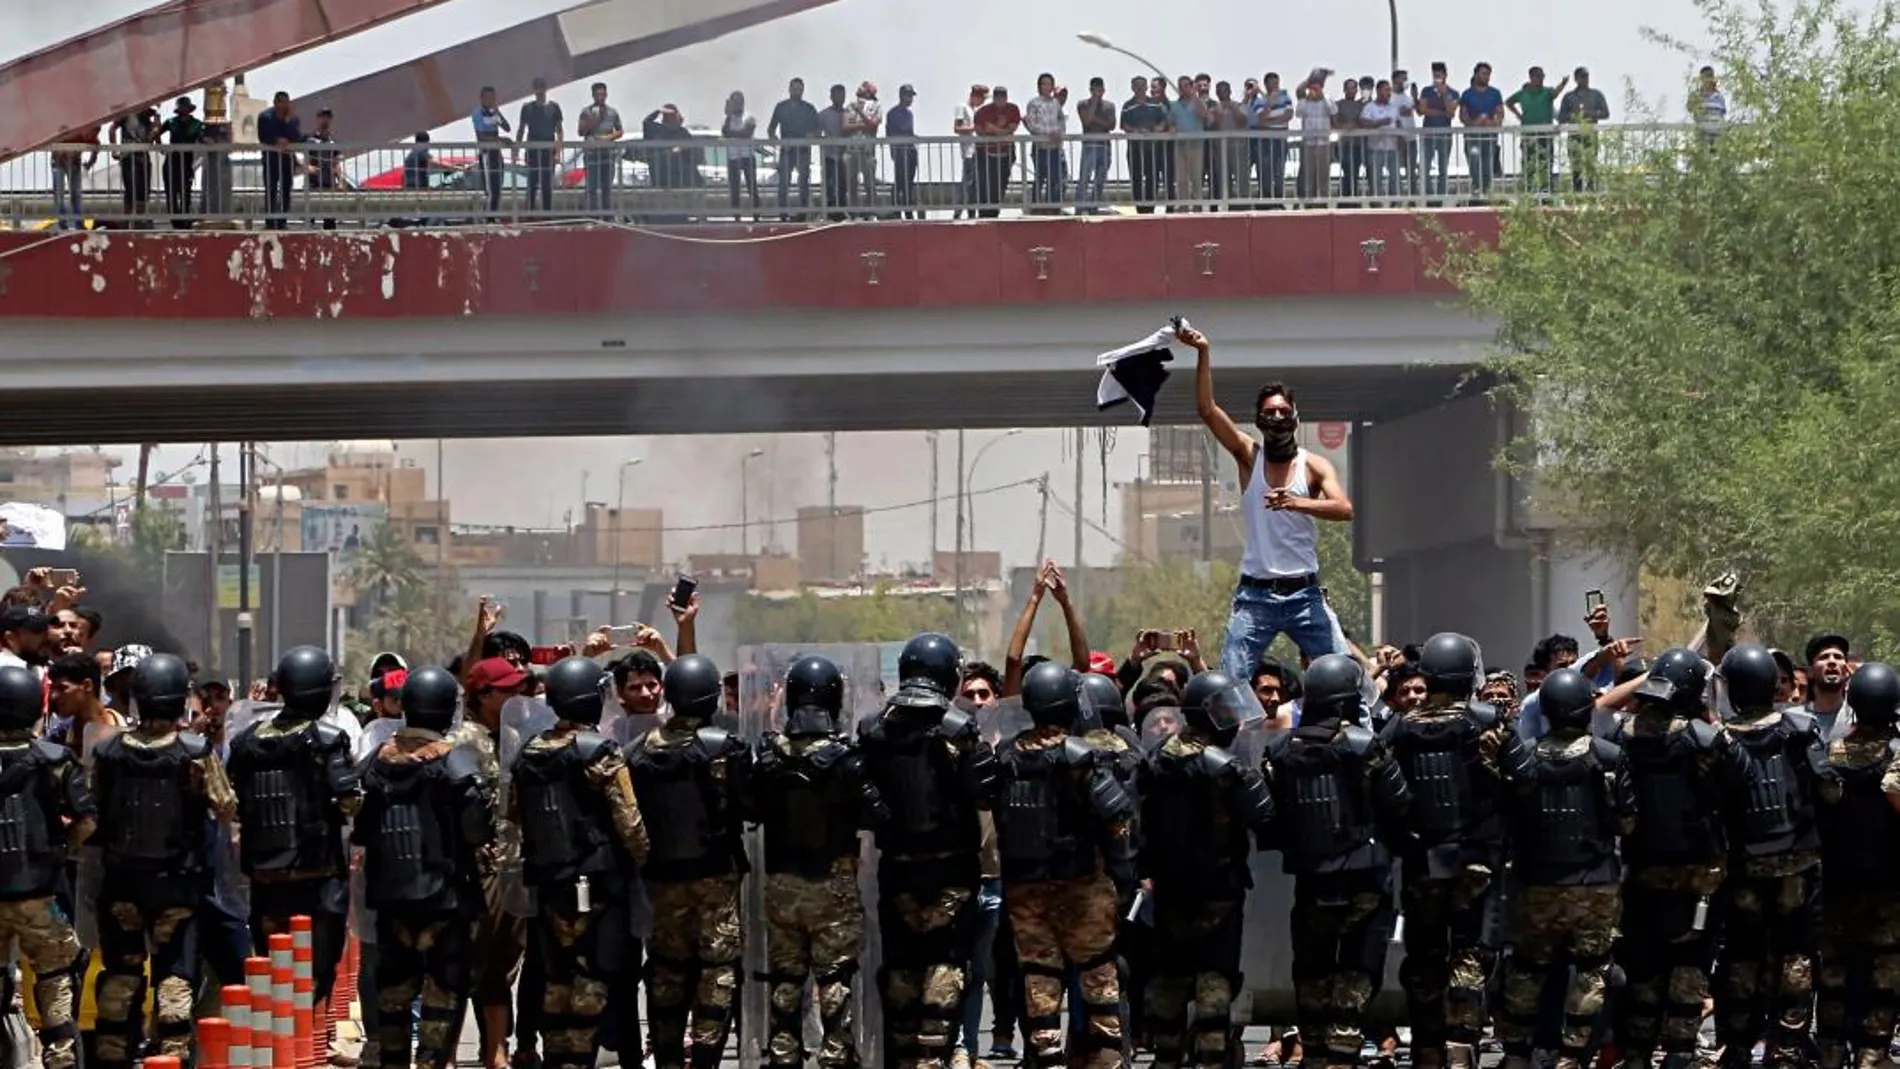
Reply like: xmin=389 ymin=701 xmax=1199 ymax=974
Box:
xmin=91 ymin=722 xmax=238 ymax=1065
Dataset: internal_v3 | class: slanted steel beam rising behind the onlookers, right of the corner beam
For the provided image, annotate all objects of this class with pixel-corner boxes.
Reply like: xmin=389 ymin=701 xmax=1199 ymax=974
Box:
xmin=300 ymin=0 xmax=832 ymax=142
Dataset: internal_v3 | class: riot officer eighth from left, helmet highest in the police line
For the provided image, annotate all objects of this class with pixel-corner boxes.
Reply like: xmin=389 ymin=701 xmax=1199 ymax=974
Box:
xmin=859 ymin=634 xmax=996 ymax=1069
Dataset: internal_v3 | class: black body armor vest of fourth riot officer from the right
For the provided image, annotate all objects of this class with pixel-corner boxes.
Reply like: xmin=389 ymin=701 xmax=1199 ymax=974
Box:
xmin=1512 ymin=739 xmax=1621 ymax=885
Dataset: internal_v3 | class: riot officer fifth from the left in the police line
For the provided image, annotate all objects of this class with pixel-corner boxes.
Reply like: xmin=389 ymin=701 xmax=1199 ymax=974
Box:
xmin=513 ymin=657 xmax=648 ymax=1069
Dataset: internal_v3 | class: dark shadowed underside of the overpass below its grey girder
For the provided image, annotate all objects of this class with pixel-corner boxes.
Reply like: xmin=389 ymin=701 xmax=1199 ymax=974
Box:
xmin=26 ymin=359 xmax=1473 ymax=446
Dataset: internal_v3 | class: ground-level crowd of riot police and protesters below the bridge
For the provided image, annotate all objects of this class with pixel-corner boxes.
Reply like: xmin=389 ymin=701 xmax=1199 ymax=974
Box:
xmin=0 ymin=328 xmax=1900 ymax=1069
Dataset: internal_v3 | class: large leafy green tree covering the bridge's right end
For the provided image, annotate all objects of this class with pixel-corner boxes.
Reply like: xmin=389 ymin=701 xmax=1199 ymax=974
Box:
xmin=1442 ymin=0 xmax=1900 ymax=649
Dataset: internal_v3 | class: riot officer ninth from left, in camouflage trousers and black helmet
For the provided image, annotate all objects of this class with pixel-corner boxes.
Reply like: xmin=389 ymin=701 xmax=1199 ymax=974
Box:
xmin=994 ymin=661 xmax=1134 ymax=1069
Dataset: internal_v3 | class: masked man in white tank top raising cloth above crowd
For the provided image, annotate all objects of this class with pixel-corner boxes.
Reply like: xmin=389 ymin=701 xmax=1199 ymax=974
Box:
xmin=1180 ymin=328 xmax=1353 ymax=680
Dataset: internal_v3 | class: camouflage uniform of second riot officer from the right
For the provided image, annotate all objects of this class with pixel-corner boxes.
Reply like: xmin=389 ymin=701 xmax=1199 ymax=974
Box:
xmin=1716 ymin=712 xmax=1839 ymax=1065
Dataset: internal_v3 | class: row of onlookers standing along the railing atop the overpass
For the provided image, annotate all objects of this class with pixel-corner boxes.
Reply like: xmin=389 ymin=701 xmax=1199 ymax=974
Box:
xmin=49 ymin=61 xmax=1727 ymax=228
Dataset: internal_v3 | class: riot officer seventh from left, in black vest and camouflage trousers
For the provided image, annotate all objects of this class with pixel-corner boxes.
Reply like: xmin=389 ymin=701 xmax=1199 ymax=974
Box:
xmin=749 ymin=657 xmax=882 ymax=1069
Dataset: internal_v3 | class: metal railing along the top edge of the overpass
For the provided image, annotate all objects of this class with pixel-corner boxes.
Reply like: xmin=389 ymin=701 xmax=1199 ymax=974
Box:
xmin=0 ymin=123 xmax=1718 ymax=230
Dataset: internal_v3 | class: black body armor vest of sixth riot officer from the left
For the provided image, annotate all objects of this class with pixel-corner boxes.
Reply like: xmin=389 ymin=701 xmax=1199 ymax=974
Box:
xmin=627 ymin=727 xmax=735 ymax=879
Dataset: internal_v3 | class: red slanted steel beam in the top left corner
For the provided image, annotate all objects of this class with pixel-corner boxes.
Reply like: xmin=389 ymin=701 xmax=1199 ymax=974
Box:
xmin=0 ymin=0 xmax=447 ymax=159
